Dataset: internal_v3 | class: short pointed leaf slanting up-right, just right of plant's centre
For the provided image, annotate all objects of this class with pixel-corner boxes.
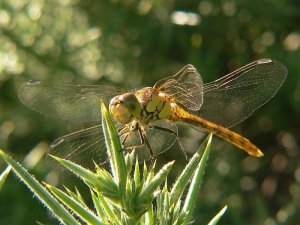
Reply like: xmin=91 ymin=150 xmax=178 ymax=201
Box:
xmin=140 ymin=161 xmax=174 ymax=202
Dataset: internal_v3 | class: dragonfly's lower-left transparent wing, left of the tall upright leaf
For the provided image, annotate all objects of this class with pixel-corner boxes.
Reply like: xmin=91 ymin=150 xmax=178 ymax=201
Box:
xmin=49 ymin=125 xmax=107 ymax=169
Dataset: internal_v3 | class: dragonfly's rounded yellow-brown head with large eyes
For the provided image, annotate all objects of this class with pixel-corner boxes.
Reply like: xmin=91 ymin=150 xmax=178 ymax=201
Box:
xmin=109 ymin=93 xmax=142 ymax=124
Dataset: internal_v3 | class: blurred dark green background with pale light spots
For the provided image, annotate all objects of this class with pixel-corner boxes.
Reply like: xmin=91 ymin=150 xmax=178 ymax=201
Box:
xmin=0 ymin=0 xmax=300 ymax=225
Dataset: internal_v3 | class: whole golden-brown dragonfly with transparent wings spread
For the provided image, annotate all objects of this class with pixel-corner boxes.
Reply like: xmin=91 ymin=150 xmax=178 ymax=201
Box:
xmin=19 ymin=58 xmax=287 ymax=166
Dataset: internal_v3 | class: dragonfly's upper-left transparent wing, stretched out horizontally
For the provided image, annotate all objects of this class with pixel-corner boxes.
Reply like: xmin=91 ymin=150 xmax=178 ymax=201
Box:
xmin=19 ymin=81 xmax=124 ymax=122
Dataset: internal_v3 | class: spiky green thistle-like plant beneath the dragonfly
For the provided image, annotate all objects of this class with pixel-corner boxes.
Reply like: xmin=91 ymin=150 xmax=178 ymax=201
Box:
xmin=0 ymin=104 xmax=226 ymax=225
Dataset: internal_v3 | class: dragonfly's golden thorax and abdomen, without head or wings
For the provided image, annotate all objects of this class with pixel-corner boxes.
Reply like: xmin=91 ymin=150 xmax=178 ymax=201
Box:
xmin=120 ymin=87 xmax=263 ymax=157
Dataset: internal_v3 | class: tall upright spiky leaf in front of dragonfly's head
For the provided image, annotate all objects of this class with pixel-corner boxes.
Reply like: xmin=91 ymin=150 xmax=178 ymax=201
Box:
xmin=101 ymin=102 xmax=127 ymax=195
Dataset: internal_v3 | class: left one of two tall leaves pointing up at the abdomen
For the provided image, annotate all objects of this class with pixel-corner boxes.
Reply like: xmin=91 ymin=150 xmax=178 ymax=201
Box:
xmin=170 ymin=134 xmax=212 ymax=204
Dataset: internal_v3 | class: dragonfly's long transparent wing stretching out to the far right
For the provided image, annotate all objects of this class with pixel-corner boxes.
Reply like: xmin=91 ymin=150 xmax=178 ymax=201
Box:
xmin=197 ymin=59 xmax=287 ymax=127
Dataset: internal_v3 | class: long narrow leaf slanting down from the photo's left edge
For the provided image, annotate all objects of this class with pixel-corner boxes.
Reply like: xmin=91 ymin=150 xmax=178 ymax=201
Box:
xmin=0 ymin=150 xmax=79 ymax=225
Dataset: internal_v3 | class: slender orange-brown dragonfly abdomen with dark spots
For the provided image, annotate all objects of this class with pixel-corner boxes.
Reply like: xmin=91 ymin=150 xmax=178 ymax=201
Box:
xmin=175 ymin=107 xmax=263 ymax=157
